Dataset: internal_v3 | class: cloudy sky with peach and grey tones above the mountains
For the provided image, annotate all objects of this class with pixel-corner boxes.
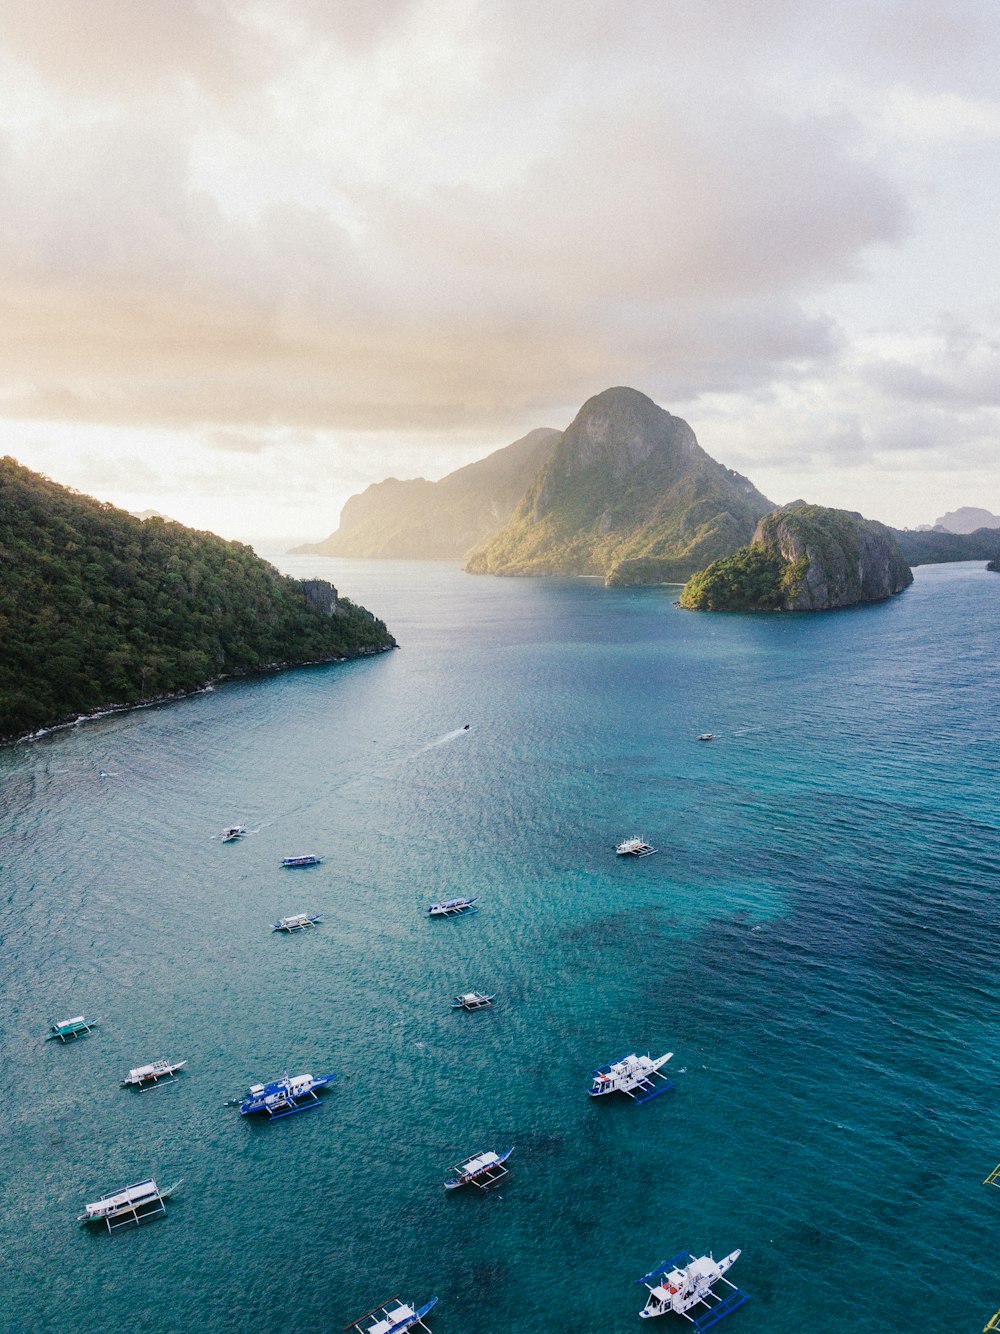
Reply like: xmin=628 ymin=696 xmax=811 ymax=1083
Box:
xmin=0 ymin=0 xmax=1000 ymax=547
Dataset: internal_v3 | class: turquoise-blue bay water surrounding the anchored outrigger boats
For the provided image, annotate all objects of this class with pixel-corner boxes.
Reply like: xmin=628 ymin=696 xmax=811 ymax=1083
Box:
xmin=0 ymin=558 xmax=1000 ymax=1334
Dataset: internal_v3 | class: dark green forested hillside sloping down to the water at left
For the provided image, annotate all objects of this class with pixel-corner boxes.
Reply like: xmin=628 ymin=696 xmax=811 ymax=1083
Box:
xmin=0 ymin=458 xmax=395 ymax=740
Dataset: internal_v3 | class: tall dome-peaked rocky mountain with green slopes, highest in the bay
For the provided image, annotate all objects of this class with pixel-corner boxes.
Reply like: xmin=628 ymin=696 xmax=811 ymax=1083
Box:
xmin=465 ymin=388 xmax=773 ymax=583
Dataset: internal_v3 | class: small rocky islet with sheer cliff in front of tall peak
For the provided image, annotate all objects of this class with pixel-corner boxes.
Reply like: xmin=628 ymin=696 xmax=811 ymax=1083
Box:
xmin=680 ymin=500 xmax=913 ymax=611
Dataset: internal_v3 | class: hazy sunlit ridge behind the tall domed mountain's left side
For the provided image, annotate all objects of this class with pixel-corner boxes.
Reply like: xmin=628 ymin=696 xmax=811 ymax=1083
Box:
xmin=295 ymin=427 xmax=559 ymax=560
